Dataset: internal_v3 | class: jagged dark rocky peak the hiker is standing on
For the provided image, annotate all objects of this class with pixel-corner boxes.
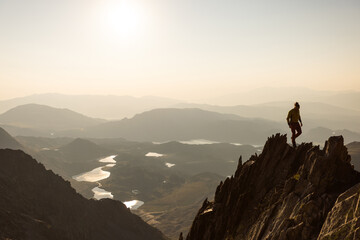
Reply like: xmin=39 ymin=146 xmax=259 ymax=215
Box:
xmin=184 ymin=135 xmax=360 ymax=240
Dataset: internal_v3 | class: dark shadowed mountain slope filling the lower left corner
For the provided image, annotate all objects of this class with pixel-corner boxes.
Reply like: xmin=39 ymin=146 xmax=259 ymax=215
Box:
xmin=0 ymin=149 xmax=165 ymax=240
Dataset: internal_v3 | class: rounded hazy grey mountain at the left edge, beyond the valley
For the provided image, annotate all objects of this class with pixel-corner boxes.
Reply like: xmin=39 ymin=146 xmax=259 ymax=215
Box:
xmin=0 ymin=104 xmax=104 ymax=131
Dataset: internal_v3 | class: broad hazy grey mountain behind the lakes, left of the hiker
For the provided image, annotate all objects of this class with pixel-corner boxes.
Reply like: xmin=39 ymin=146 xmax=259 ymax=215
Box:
xmin=84 ymin=109 xmax=284 ymax=144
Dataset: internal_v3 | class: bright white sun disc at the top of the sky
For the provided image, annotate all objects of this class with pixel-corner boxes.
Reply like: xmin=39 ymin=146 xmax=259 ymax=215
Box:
xmin=104 ymin=1 xmax=144 ymax=38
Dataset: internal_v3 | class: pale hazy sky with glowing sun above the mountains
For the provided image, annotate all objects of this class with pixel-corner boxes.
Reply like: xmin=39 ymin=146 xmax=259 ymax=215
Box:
xmin=0 ymin=0 xmax=360 ymax=99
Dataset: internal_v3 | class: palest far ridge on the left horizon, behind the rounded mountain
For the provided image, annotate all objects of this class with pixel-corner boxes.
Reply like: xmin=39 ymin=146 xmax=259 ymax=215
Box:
xmin=0 ymin=93 xmax=181 ymax=119
